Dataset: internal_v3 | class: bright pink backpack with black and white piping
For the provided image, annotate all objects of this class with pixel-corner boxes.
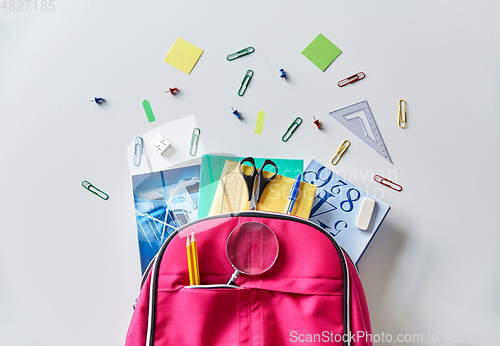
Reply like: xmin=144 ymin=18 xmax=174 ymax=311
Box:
xmin=125 ymin=211 xmax=372 ymax=346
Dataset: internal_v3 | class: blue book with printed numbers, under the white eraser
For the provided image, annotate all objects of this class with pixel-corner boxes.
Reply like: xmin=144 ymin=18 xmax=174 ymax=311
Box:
xmin=304 ymin=160 xmax=391 ymax=263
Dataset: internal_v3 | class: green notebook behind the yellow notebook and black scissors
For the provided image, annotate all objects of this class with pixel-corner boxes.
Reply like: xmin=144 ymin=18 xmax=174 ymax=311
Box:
xmin=198 ymin=155 xmax=304 ymax=219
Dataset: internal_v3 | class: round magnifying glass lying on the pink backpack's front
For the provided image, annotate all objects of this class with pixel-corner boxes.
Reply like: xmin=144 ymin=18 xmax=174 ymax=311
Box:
xmin=226 ymin=222 xmax=279 ymax=285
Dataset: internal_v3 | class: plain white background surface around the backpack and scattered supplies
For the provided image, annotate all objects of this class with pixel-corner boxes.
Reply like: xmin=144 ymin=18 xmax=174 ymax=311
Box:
xmin=0 ymin=0 xmax=500 ymax=346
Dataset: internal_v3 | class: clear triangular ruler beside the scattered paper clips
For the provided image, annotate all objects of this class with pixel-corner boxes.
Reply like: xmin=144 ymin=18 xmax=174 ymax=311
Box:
xmin=330 ymin=100 xmax=392 ymax=163
